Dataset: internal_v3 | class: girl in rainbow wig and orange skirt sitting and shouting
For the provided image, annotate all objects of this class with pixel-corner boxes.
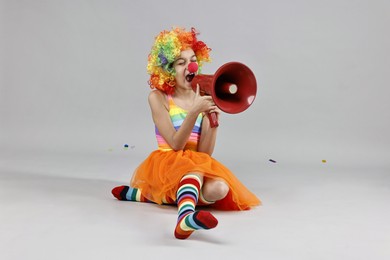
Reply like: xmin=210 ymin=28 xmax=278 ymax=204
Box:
xmin=112 ymin=28 xmax=260 ymax=239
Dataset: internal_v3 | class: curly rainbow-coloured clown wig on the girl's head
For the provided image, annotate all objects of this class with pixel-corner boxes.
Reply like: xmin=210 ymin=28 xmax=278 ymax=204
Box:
xmin=147 ymin=28 xmax=211 ymax=94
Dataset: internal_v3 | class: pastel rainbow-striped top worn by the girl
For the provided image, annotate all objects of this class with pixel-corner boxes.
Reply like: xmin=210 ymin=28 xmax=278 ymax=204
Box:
xmin=155 ymin=95 xmax=203 ymax=151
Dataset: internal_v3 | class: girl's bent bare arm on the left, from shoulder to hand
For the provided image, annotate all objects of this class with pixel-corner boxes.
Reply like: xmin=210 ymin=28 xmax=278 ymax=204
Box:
xmin=148 ymin=88 xmax=214 ymax=151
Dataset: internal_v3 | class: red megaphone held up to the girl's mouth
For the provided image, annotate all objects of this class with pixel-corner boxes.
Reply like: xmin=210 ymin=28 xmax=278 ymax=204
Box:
xmin=188 ymin=62 xmax=257 ymax=127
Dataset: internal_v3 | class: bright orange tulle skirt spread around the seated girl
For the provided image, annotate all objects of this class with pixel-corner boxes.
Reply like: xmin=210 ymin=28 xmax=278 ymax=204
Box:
xmin=130 ymin=150 xmax=261 ymax=210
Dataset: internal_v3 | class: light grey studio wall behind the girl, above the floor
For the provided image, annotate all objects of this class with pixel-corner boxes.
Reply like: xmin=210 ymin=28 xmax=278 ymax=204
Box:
xmin=0 ymin=0 xmax=390 ymax=167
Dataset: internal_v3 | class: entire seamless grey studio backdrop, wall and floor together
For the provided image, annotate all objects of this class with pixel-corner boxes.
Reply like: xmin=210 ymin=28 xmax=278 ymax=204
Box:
xmin=0 ymin=0 xmax=390 ymax=259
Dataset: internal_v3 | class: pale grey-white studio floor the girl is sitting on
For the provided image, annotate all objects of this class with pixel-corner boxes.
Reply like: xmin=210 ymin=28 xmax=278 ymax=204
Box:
xmin=0 ymin=152 xmax=390 ymax=260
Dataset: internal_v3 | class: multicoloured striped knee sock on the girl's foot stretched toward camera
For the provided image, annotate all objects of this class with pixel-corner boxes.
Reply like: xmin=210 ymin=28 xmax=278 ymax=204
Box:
xmin=175 ymin=173 xmax=218 ymax=239
